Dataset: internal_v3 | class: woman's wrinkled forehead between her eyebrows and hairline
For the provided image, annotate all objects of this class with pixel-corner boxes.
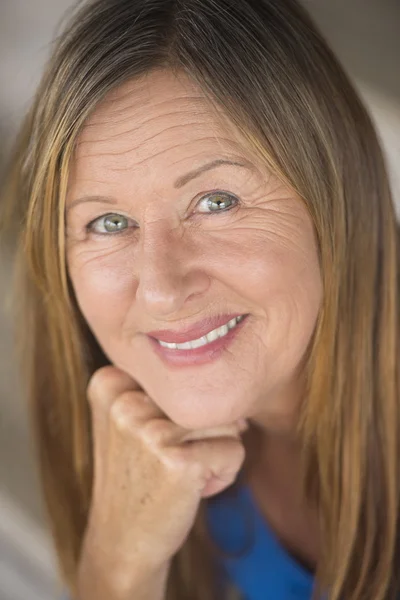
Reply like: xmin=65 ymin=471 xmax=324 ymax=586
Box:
xmin=75 ymin=71 xmax=244 ymax=174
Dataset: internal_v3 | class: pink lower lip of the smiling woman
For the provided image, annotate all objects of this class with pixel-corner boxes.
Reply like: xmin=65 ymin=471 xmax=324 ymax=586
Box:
xmin=148 ymin=315 xmax=248 ymax=367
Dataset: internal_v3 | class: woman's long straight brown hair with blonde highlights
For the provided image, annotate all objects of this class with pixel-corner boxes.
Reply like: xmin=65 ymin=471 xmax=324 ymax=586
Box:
xmin=4 ymin=0 xmax=400 ymax=600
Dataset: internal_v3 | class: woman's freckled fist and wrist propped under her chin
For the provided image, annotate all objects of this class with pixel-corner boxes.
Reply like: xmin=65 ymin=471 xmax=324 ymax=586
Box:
xmin=77 ymin=366 xmax=246 ymax=589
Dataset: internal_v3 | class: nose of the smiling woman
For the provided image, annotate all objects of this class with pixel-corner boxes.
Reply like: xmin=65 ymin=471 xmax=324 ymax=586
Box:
xmin=136 ymin=223 xmax=210 ymax=319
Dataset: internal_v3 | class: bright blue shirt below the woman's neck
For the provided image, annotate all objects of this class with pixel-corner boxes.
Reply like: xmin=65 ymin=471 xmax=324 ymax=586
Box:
xmin=206 ymin=484 xmax=314 ymax=600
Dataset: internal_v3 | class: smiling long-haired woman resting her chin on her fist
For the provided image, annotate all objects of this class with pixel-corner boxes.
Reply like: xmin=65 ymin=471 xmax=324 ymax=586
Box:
xmin=1 ymin=0 xmax=400 ymax=600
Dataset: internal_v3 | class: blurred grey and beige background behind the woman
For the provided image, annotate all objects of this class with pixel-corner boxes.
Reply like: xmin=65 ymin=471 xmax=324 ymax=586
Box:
xmin=0 ymin=0 xmax=400 ymax=600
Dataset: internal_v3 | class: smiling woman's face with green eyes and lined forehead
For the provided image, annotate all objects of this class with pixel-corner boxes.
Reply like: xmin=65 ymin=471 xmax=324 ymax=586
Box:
xmin=67 ymin=71 xmax=322 ymax=428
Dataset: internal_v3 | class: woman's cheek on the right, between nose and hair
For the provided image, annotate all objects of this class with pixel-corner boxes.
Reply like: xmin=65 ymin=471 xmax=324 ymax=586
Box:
xmin=212 ymin=227 xmax=322 ymax=364
